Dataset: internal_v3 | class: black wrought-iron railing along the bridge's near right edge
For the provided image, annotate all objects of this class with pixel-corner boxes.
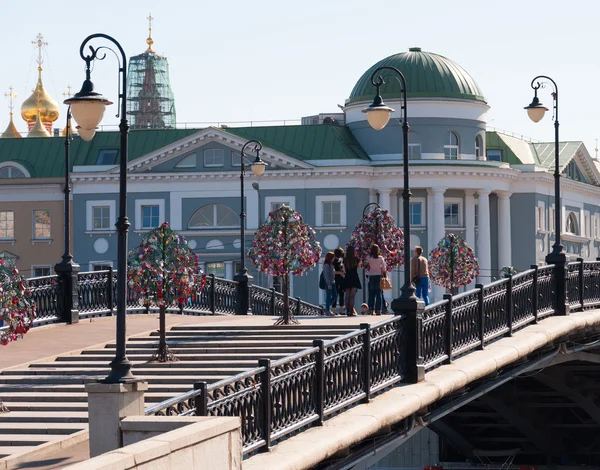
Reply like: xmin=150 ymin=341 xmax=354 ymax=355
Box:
xmin=146 ymin=259 xmax=600 ymax=454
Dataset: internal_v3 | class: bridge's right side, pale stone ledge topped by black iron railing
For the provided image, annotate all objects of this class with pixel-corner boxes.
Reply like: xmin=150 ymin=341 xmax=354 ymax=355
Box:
xmin=147 ymin=260 xmax=600 ymax=470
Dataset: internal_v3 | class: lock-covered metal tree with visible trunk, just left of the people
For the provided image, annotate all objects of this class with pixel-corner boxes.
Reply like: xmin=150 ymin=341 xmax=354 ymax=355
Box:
xmin=248 ymin=205 xmax=321 ymax=325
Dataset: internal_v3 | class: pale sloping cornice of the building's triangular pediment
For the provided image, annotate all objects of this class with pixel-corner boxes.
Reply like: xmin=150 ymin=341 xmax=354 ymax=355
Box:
xmin=122 ymin=127 xmax=313 ymax=173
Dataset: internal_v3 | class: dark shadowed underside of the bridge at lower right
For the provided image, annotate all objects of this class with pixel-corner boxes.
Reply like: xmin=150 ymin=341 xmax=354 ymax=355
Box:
xmin=430 ymin=348 xmax=600 ymax=468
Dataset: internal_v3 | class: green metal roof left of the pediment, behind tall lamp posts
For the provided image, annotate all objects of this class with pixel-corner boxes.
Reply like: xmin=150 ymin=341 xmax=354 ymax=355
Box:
xmin=0 ymin=129 xmax=198 ymax=178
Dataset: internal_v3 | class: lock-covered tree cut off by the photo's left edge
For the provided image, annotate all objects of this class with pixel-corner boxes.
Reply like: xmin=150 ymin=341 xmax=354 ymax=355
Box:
xmin=0 ymin=259 xmax=35 ymax=413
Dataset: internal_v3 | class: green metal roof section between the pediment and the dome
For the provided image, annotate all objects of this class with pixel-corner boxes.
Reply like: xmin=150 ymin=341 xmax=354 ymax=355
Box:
xmin=226 ymin=124 xmax=370 ymax=161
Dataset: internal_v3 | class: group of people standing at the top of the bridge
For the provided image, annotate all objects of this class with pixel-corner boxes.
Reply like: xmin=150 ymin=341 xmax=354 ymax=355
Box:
xmin=321 ymin=244 xmax=429 ymax=317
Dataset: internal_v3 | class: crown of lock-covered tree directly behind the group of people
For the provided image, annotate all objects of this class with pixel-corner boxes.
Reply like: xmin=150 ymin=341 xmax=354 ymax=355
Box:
xmin=346 ymin=205 xmax=404 ymax=271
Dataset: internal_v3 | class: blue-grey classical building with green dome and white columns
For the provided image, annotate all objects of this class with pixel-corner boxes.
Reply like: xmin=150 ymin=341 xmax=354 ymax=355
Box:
xmin=0 ymin=47 xmax=600 ymax=308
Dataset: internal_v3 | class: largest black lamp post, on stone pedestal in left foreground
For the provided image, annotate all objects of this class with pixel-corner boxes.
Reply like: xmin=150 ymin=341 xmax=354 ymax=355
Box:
xmin=65 ymin=33 xmax=137 ymax=383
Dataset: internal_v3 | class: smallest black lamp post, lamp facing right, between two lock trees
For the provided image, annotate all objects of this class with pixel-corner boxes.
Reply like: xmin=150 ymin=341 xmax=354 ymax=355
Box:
xmin=233 ymin=140 xmax=267 ymax=315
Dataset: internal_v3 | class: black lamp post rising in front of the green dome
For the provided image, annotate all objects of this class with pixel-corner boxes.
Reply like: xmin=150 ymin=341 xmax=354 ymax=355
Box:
xmin=363 ymin=65 xmax=424 ymax=312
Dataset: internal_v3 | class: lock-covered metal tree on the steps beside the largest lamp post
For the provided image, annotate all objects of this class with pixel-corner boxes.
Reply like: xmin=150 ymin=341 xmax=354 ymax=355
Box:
xmin=127 ymin=222 xmax=206 ymax=362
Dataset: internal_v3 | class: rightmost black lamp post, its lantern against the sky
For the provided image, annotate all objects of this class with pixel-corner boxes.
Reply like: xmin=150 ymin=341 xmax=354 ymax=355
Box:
xmin=525 ymin=75 xmax=569 ymax=315
